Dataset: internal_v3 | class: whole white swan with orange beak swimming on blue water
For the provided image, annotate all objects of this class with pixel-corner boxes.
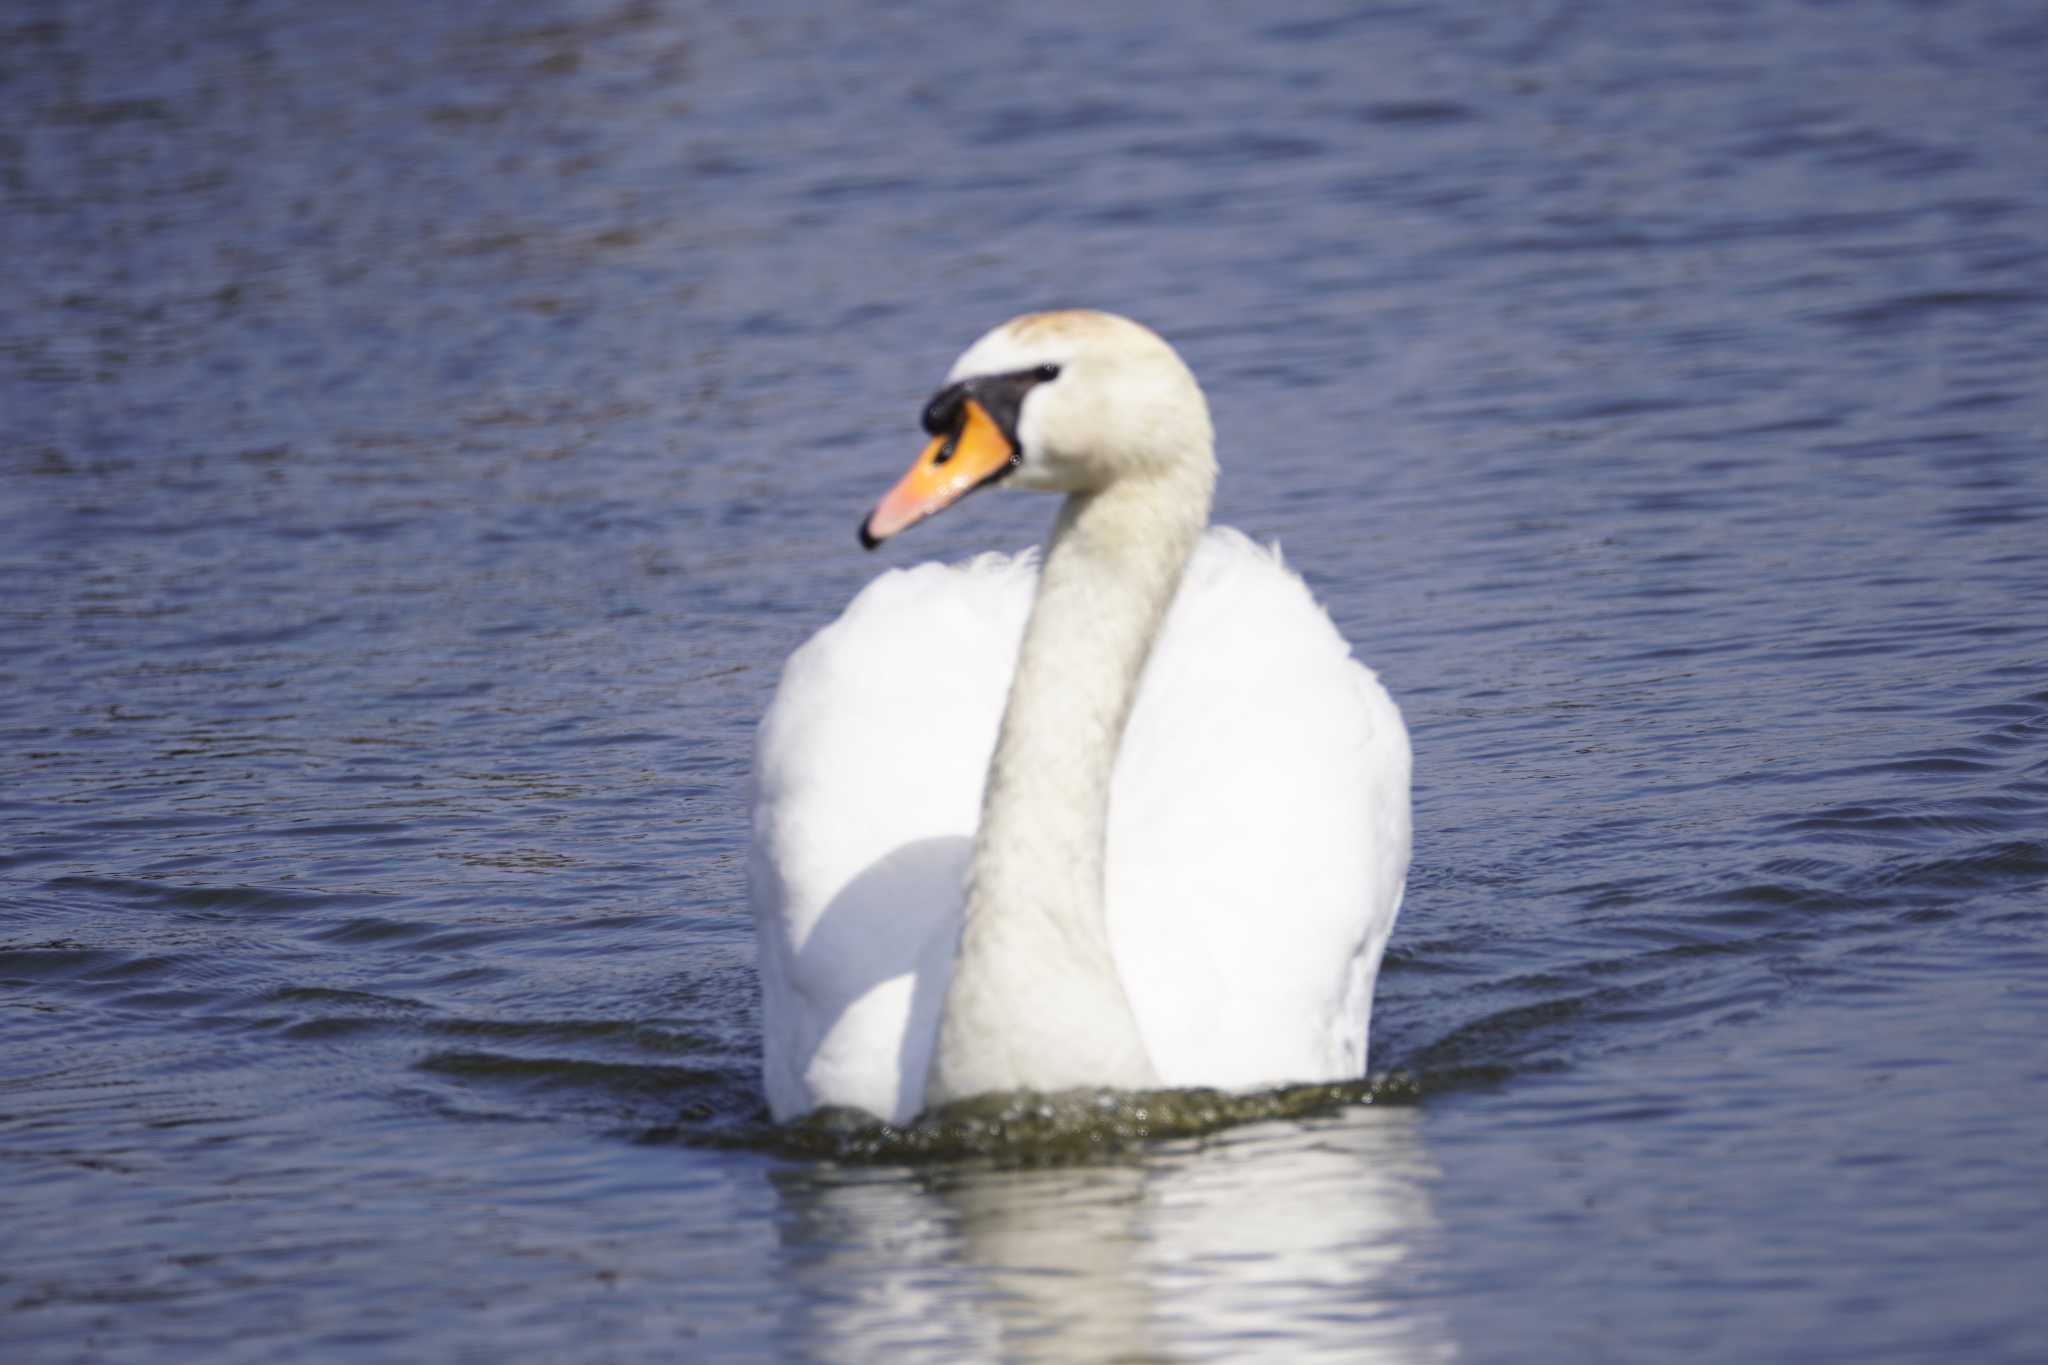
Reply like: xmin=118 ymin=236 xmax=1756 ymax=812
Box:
xmin=748 ymin=311 xmax=1409 ymax=1121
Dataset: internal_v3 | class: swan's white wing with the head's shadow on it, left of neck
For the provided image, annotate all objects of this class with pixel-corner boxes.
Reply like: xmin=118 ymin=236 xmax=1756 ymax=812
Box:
xmin=748 ymin=555 xmax=1036 ymax=1121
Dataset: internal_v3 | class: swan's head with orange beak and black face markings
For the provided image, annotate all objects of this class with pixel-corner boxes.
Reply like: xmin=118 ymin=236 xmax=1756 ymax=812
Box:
xmin=860 ymin=309 xmax=1217 ymax=548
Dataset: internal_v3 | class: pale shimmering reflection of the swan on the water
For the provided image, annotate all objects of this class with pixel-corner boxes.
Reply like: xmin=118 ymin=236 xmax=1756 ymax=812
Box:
xmin=778 ymin=1107 xmax=1456 ymax=1361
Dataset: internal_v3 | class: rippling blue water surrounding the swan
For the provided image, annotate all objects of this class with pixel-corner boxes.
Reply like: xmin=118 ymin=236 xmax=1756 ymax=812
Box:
xmin=0 ymin=0 xmax=2048 ymax=1361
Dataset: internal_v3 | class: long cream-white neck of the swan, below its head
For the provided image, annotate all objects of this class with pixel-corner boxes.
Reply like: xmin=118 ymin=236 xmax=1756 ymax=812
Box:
xmin=926 ymin=464 xmax=1214 ymax=1103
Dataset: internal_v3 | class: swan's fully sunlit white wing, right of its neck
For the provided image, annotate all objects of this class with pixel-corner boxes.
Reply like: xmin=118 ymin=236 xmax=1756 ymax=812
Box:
xmin=1106 ymin=528 xmax=1409 ymax=1089
